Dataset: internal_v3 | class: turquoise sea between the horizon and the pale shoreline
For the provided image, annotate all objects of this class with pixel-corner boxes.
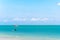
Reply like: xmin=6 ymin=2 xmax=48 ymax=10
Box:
xmin=0 ymin=25 xmax=60 ymax=37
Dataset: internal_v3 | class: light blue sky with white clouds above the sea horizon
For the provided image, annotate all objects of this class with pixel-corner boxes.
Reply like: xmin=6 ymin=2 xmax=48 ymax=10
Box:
xmin=0 ymin=0 xmax=60 ymax=25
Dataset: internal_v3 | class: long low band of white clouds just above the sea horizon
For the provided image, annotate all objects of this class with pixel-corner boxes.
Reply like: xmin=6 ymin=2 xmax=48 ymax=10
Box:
xmin=0 ymin=17 xmax=49 ymax=23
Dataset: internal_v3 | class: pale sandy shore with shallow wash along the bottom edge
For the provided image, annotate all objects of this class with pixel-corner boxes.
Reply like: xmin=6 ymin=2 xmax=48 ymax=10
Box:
xmin=0 ymin=34 xmax=60 ymax=40
